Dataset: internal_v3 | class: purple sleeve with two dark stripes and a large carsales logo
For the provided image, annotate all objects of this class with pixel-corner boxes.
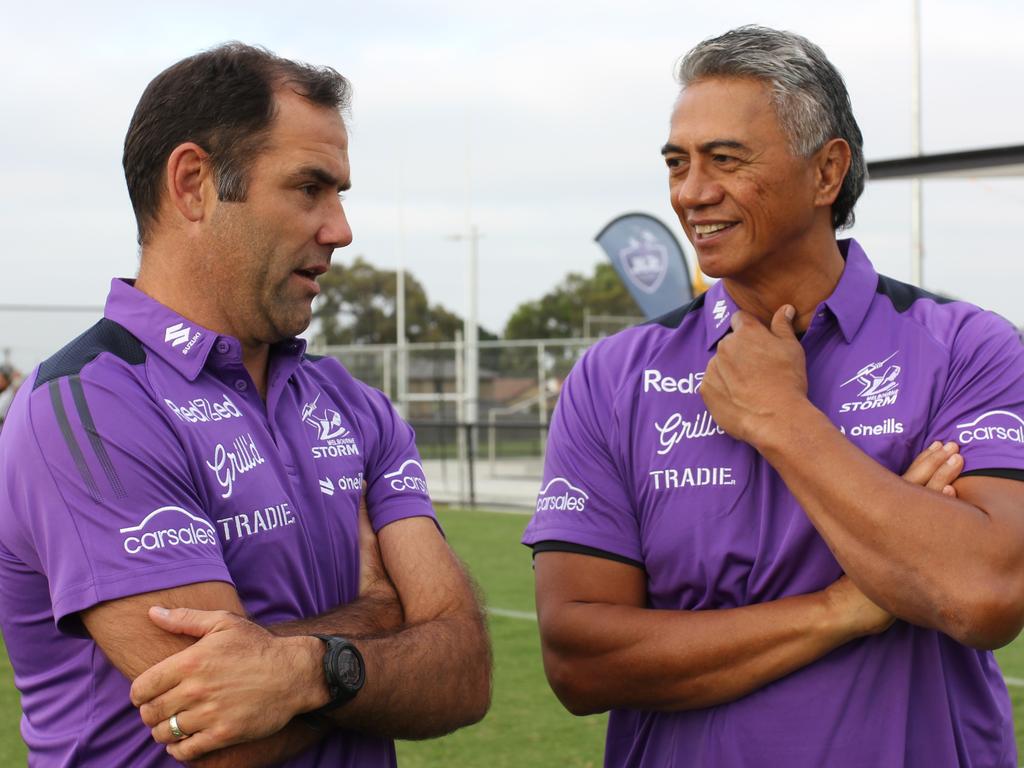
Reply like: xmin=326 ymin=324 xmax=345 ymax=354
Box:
xmin=0 ymin=368 xmax=231 ymax=632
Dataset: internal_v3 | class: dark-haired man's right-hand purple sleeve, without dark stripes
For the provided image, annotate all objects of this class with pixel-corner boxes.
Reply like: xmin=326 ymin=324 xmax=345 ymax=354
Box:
xmin=367 ymin=388 xmax=437 ymax=530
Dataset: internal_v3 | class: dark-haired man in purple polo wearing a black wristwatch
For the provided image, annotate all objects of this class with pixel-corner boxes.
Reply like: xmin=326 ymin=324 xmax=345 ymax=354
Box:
xmin=0 ymin=44 xmax=490 ymax=768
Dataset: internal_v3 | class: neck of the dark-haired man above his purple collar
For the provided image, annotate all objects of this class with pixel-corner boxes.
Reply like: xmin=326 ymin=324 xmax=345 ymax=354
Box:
xmin=135 ymin=241 xmax=270 ymax=399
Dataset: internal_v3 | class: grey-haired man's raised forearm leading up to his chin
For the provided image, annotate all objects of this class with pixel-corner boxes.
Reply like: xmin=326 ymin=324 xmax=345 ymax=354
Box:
xmin=756 ymin=403 xmax=1021 ymax=645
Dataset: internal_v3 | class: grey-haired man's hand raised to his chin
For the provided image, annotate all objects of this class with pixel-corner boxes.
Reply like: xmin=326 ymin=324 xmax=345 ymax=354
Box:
xmin=700 ymin=304 xmax=807 ymax=444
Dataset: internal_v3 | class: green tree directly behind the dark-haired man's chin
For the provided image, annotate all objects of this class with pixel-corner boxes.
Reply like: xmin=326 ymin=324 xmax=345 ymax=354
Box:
xmin=313 ymin=256 xmax=497 ymax=344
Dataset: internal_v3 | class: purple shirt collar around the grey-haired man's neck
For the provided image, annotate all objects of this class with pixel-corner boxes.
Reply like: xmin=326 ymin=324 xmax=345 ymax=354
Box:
xmin=703 ymin=238 xmax=879 ymax=349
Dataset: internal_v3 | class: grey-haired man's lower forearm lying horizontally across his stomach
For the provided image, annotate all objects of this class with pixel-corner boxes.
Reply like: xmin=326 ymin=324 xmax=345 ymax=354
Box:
xmin=541 ymin=592 xmax=860 ymax=715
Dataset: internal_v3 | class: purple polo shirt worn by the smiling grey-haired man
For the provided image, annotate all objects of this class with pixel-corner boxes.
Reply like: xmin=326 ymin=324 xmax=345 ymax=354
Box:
xmin=523 ymin=241 xmax=1024 ymax=768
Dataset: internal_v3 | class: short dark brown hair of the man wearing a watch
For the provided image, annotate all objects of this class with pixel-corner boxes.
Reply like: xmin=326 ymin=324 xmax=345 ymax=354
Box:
xmin=122 ymin=42 xmax=351 ymax=245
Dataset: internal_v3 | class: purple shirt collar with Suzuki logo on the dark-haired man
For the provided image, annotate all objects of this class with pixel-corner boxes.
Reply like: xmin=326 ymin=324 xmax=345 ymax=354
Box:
xmin=103 ymin=278 xmax=306 ymax=382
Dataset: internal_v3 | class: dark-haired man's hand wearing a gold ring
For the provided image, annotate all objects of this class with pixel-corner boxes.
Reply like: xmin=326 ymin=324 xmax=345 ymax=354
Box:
xmin=131 ymin=607 xmax=327 ymax=761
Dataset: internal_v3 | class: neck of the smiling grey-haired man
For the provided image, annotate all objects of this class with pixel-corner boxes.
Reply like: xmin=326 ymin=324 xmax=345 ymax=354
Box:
xmin=722 ymin=230 xmax=846 ymax=332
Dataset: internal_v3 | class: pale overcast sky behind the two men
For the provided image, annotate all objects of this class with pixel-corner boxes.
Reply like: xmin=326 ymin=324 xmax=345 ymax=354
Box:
xmin=0 ymin=0 xmax=1024 ymax=368
